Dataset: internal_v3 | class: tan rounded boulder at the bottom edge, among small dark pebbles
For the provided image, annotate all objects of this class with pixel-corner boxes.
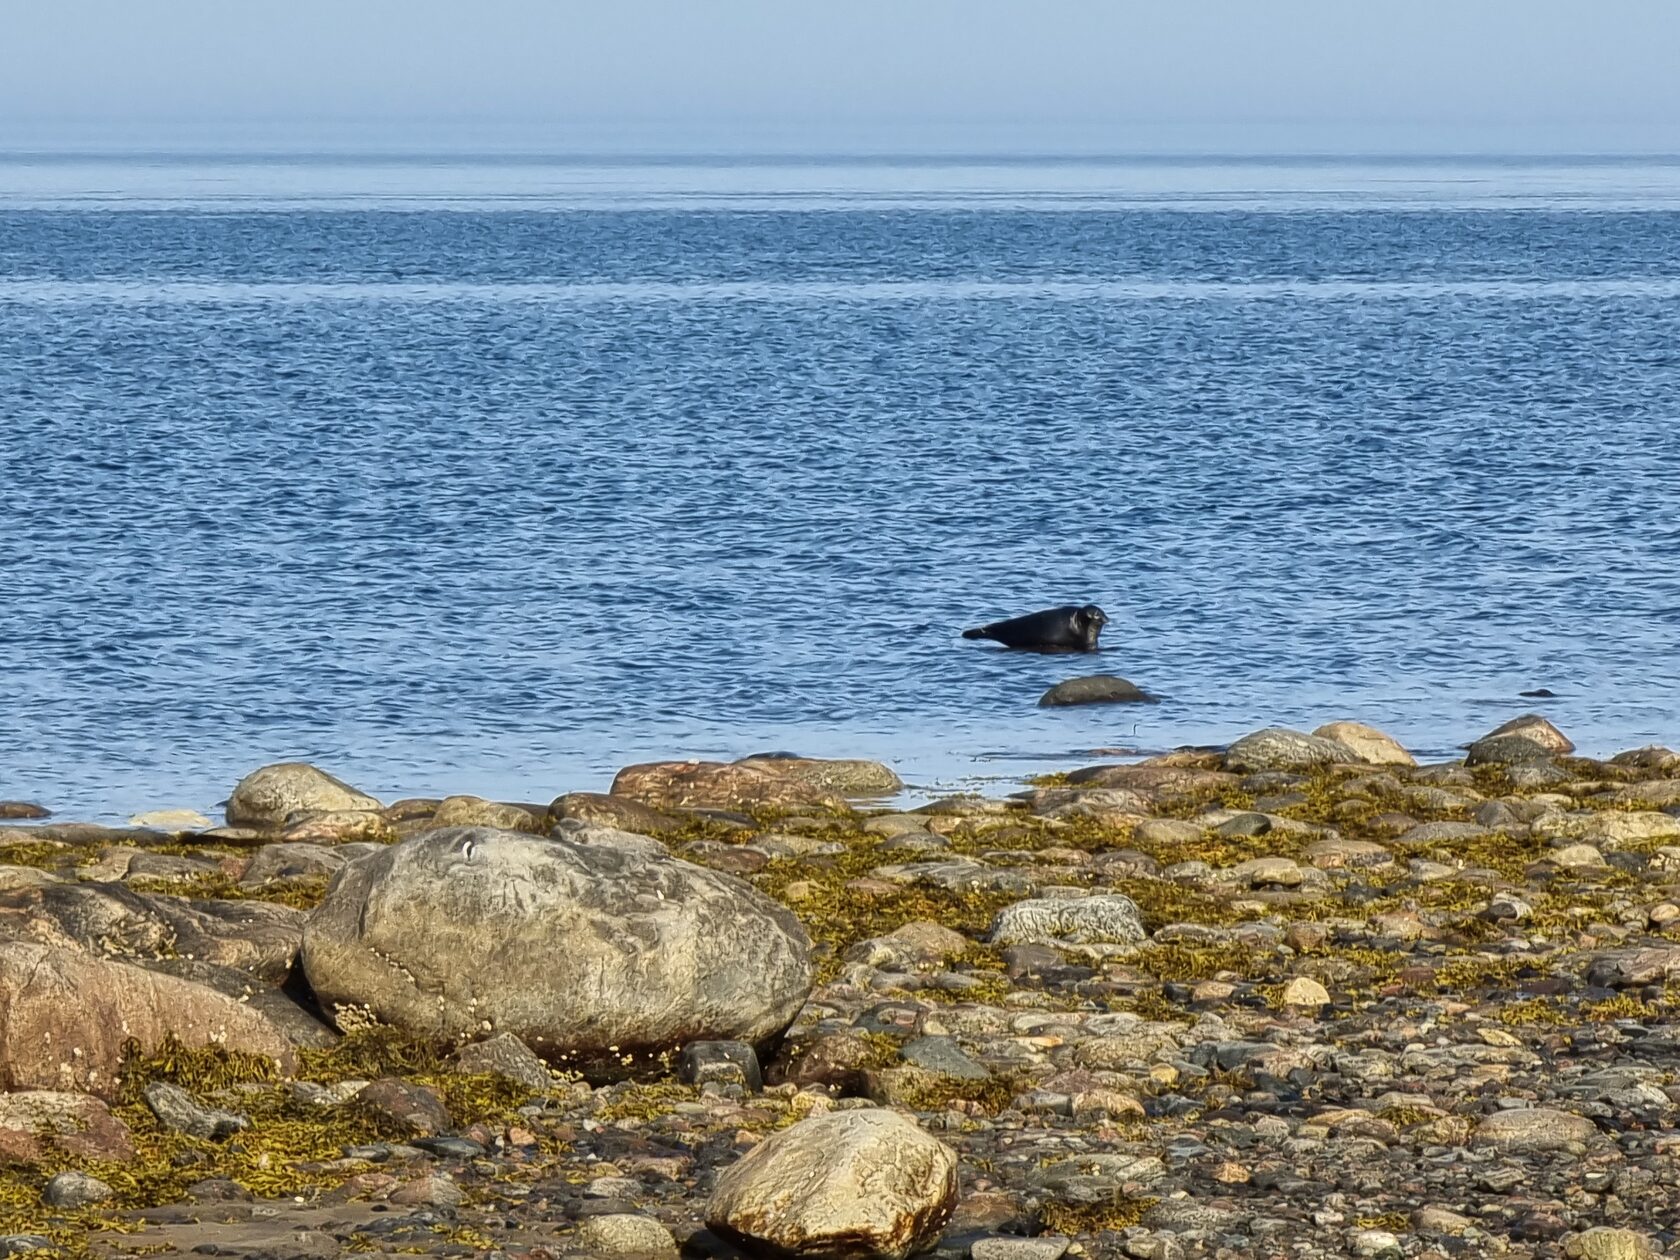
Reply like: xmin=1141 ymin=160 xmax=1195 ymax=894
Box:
xmin=706 ymin=1109 xmax=958 ymax=1260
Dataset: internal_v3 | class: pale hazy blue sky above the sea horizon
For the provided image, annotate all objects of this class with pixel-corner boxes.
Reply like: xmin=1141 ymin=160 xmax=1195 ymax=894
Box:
xmin=0 ymin=0 xmax=1680 ymax=153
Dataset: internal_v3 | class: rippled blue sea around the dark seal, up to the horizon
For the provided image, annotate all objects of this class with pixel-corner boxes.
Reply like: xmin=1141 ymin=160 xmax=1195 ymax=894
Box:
xmin=0 ymin=156 xmax=1680 ymax=816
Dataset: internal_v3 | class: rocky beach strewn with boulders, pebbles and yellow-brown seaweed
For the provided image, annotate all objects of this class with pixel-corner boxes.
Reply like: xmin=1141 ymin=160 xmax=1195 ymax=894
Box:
xmin=0 ymin=714 xmax=1680 ymax=1260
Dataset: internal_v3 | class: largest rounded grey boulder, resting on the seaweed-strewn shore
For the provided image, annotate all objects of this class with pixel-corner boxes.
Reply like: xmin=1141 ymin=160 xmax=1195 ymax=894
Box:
xmin=302 ymin=827 xmax=811 ymax=1068
